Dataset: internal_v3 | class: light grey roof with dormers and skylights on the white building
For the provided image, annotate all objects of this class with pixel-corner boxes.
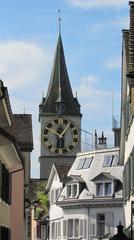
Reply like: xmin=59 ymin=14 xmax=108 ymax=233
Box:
xmin=58 ymin=147 xmax=123 ymax=202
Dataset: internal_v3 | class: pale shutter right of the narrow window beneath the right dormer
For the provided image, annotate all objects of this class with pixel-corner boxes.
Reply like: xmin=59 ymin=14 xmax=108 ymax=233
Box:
xmin=105 ymin=212 xmax=114 ymax=237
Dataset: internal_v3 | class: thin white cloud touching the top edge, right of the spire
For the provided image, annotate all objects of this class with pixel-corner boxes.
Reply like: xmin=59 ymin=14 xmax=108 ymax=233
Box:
xmin=67 ymin=0 xmax=127 ymax=10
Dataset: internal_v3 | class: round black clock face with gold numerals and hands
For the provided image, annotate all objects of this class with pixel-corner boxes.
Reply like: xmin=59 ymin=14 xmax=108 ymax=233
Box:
xmin=42 ymin=118 xmax=79 ymax=155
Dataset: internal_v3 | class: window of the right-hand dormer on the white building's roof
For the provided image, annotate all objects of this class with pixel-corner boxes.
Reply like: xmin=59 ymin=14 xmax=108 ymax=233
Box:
xmin=96 ymin=182 xmax=112 ymax=196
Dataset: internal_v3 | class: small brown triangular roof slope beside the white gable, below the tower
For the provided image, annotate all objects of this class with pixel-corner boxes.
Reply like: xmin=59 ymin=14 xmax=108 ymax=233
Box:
xmin=54 ymin=163 xmax=71 ymax=182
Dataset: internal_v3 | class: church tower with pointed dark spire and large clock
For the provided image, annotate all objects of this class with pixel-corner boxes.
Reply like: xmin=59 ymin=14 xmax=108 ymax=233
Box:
xmin=39 ymin=27 xmax=82 ymax=179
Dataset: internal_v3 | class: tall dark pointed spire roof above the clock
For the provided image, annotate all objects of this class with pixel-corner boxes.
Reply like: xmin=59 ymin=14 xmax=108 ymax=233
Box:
xmin=39 ymin=35 xmax=80 ymax=115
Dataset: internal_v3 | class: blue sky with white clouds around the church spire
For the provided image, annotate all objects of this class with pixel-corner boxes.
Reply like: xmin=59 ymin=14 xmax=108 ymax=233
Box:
xmin=0 ymin=0 xmax=129 ymax=177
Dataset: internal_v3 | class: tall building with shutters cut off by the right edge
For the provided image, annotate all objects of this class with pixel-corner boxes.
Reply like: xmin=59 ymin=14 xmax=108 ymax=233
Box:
xmin=120 ymin=1 xmax=134 ymax=239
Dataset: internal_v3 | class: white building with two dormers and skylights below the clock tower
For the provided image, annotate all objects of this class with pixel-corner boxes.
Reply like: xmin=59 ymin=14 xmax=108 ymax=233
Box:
xmin=47 ymin=145 xmax=125 ymax=240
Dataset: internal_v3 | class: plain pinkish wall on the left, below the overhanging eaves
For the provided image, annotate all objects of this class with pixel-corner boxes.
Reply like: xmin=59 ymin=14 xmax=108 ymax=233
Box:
xmin=11 ymin=167 xmax=24 ymax=240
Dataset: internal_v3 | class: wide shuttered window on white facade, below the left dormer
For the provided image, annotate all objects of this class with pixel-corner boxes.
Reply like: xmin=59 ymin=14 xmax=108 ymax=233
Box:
xmin=63 ymin=218 xmax=87 ymax=239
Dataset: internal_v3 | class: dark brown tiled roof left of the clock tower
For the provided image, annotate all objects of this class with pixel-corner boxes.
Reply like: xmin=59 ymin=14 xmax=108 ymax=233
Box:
xmin=5 ymin=114 xmax=33 ymax=151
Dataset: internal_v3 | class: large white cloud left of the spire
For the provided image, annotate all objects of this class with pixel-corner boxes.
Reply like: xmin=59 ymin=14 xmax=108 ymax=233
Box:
xmin=0 ymin=41 xmax=50 ymax=90
